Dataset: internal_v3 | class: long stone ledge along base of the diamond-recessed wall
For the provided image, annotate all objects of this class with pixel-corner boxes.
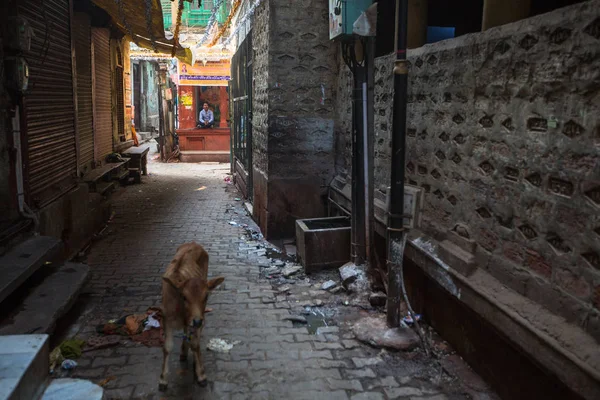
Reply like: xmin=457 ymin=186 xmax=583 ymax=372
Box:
xmin=404 ymin=232 xmax=600 ymax=400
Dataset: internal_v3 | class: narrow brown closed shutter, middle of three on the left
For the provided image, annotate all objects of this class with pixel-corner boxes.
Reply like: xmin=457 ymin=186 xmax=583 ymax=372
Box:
xmin=73 ymin=12 xmax=94 ymax=173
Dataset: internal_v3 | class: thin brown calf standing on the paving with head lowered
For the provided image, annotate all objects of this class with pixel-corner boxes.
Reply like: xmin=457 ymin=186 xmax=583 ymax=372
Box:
xmin=158 ymin=243 xmax=225 ymax=391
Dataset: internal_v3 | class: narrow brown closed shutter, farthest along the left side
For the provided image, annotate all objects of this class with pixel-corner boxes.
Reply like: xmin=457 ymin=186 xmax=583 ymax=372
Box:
xmin=92 ymin=28 xmax=113 ymax=162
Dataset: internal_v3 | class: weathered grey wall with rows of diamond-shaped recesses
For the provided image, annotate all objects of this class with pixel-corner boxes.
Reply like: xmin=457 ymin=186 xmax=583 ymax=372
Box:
xmin=336 ymin=0 xmax=600 ymax=340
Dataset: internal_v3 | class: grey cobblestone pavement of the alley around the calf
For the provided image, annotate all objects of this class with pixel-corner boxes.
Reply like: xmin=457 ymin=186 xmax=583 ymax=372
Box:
xmin=64 ymin=150 xmax=496 ymax=400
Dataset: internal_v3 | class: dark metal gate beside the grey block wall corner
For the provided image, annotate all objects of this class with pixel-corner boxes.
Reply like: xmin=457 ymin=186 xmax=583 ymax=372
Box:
xmin=231 ymin=31 xmax=252 ymax=200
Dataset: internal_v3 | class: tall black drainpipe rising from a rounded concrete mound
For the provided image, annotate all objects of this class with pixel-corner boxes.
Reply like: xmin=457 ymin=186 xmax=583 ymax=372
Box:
xmin=387 ymin=0 xmax=408 ymax=327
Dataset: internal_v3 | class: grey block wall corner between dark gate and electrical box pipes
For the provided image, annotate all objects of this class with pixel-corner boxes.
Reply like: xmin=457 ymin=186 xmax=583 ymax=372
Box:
xmin=253 ymin=0 xmax=337 ymax=238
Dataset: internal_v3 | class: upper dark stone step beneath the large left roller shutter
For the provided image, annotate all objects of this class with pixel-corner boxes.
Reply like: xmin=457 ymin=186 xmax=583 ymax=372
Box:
xmin=0 ymin=236 xmax=62 ymax=303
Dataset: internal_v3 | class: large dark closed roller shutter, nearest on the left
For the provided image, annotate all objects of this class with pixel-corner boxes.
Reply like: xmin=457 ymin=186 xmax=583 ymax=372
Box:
xmin=19 ymin=0 xmax=77 ymax=207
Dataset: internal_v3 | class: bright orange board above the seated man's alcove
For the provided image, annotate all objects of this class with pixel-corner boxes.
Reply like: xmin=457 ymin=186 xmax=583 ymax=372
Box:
xmin=177 ymin=60 xmax=231 ymax=86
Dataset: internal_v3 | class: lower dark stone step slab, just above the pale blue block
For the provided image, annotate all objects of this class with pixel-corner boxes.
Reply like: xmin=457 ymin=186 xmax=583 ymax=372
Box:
xmin=0 ymin=263 xmax=90 ymax=335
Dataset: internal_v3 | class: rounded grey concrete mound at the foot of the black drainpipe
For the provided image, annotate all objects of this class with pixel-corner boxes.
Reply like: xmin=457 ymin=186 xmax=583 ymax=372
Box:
xmin=352 ymin=316 xmax=419 ymax=350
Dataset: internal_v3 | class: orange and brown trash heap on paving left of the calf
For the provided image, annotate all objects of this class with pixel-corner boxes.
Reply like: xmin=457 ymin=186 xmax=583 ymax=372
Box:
xmin=96 ymin=307 xmax=164 ymax=347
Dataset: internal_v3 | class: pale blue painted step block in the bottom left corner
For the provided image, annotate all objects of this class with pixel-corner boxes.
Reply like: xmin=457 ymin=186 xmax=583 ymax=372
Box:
xmin=0 ymin=335 xmax=49 ymax=400
